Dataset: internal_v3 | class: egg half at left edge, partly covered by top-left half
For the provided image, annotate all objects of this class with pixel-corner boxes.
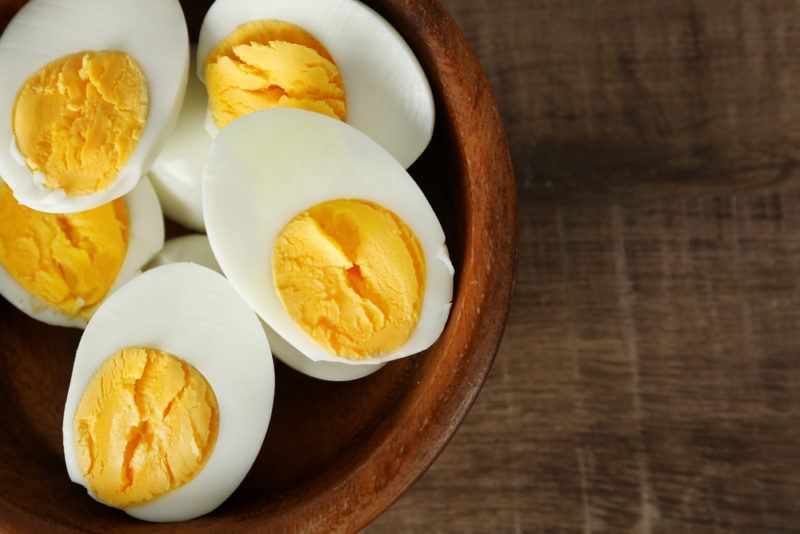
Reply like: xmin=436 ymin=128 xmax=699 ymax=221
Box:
xmin=0 ymin=179 xmax=164 ymax=328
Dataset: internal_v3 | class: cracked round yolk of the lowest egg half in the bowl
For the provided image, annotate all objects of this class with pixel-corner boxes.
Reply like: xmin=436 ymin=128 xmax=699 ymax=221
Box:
xmin=73 ymin=348 xmax=219 ymax=507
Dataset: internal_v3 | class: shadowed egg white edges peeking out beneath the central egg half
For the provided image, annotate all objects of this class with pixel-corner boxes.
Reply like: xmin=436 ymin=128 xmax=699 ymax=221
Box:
xmin=150 ymin=235 xmax=384 ymax=382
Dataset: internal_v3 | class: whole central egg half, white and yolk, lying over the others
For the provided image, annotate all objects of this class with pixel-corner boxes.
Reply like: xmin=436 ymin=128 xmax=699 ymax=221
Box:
xmin=203 ymin=109 xmax=454 ymax=365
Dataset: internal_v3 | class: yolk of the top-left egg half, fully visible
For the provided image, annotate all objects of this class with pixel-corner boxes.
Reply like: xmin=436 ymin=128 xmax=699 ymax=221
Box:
xmin=13 ymin=51 xmax=148 ymax=196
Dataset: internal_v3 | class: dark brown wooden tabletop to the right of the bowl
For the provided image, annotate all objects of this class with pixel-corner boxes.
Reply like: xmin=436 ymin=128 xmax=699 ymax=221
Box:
xmin=368 ymin=0 xmax=800 ymax=533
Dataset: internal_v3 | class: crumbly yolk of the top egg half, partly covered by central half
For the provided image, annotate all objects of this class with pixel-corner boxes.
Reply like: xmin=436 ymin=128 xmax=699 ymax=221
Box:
xmin=205 ymin=20 xmax=347 ymax=128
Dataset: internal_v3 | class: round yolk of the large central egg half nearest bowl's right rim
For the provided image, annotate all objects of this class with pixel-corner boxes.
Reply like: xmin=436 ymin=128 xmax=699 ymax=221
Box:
xmin=272 ymin=200 xmax=425 ymax=359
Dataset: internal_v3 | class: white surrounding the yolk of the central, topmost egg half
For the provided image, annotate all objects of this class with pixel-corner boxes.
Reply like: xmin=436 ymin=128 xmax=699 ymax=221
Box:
xmin=203 ymin=109 xmax=454 ymax=365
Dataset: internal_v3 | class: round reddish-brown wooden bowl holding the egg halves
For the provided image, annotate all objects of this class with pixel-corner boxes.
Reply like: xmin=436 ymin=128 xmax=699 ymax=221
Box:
xmin=0 ymin=0 xmax=516 ymax=532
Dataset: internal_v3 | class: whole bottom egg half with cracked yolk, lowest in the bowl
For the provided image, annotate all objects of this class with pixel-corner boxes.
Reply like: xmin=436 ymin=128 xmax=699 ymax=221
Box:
xmin=63 ymin=263 xmax=275 ymax=522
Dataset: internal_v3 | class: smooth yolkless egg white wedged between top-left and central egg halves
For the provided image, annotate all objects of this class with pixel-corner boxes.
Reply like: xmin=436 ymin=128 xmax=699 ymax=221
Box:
xmin=149 ymin=50 xmax=211 ymax=232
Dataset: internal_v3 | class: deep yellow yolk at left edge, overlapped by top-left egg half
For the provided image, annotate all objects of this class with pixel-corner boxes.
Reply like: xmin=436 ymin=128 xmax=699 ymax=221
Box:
xmin=0 ymin=183 xmax=129 ymax=316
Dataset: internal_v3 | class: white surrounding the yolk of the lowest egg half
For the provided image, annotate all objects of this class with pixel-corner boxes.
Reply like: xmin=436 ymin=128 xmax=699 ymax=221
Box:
xmin=63 ymin=263 xmax=275 ymax=521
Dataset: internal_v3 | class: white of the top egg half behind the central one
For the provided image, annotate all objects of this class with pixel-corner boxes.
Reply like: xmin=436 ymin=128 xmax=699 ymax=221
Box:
xmin=197 ymin=0 xmax=435 ymax=168
